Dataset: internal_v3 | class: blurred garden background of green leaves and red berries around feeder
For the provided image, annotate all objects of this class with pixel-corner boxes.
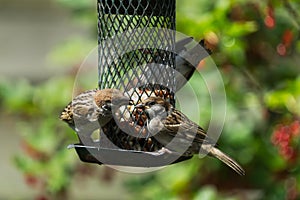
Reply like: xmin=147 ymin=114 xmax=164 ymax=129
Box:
xmin=0 ymin=0 xmax=300 ymax=200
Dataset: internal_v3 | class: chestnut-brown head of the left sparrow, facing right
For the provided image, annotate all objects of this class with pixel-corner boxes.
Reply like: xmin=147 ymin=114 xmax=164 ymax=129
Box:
xmin=94 ymin=89 xmax=132 ymax=115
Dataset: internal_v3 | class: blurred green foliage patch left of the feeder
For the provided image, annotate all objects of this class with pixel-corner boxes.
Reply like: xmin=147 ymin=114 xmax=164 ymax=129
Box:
xmin=1 ymin=77 xmax=77 ymax=194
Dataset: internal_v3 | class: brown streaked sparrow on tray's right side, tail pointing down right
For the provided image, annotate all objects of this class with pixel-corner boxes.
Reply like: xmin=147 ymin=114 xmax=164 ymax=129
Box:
xmin=136 ymin=97 xmax=245 ymax=175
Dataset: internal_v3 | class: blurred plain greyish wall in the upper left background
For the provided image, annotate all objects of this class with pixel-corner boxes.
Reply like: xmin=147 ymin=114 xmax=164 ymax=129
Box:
xmin=0 ymin=0 xmax=89 ymax=80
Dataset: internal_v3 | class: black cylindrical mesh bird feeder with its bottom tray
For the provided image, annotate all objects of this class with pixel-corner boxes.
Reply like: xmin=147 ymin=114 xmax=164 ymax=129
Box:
xmin=71 ymin=0 xmax=196 ymax=167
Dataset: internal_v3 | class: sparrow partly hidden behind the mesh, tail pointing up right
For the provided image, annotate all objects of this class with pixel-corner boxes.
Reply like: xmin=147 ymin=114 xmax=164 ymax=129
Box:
xmin=125 ymin=37 xmax=212 ymax=92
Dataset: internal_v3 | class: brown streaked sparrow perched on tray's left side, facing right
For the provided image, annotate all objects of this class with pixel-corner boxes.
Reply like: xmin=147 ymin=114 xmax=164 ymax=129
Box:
xmin=59 ymin=89 xmax=130 ymax=141
